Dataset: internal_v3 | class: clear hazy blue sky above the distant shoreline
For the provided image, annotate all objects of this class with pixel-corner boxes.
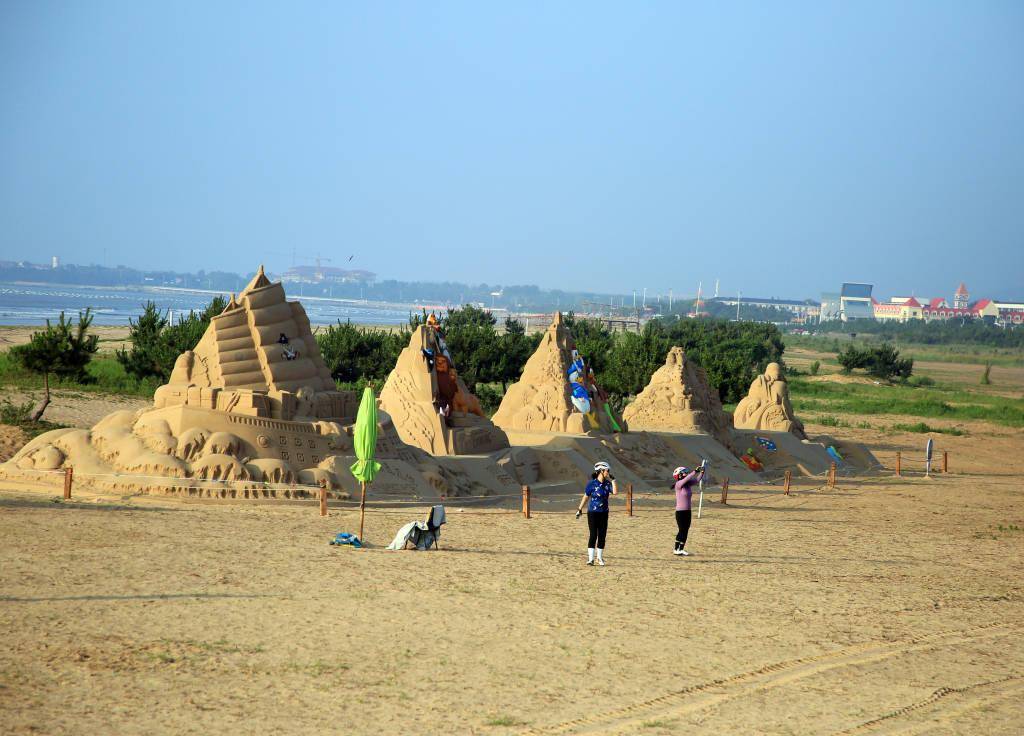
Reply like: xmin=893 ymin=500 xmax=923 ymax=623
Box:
xmin=0 ymin=0 xmax=1024 ymax=298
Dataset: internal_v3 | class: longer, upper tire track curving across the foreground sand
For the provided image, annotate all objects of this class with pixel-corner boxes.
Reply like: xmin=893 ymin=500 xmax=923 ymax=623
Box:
xmin=525 ymin=622 xmax=1017 ymax=736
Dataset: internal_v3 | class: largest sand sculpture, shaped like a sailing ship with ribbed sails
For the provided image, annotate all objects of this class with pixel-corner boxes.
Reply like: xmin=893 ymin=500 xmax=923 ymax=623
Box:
xmin=0 ymin=266 xmax=479 ymax=497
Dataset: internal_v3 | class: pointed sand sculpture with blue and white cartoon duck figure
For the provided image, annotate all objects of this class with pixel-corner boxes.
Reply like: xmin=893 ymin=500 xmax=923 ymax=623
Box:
xmin=494 ymin=312 xmax=627 ymax=434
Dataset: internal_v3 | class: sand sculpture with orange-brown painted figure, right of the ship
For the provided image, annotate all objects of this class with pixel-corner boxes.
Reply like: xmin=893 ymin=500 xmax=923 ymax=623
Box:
xmin=380 ymin=321 xmax=509 ymax=456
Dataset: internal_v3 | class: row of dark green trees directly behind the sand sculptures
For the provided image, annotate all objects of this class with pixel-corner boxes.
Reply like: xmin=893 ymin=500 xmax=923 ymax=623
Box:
xmin=12 ymin=298 xmax=783 ymax=419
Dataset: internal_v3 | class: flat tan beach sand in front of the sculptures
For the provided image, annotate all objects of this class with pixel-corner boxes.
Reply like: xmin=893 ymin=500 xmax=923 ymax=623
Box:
xmin=0 ymin=417 xmax=1024 ymax=734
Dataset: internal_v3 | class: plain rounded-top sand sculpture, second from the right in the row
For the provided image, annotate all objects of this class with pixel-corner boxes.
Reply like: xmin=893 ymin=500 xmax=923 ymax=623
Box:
xmin=623 ymin=347 xmax=732 ymax=447
